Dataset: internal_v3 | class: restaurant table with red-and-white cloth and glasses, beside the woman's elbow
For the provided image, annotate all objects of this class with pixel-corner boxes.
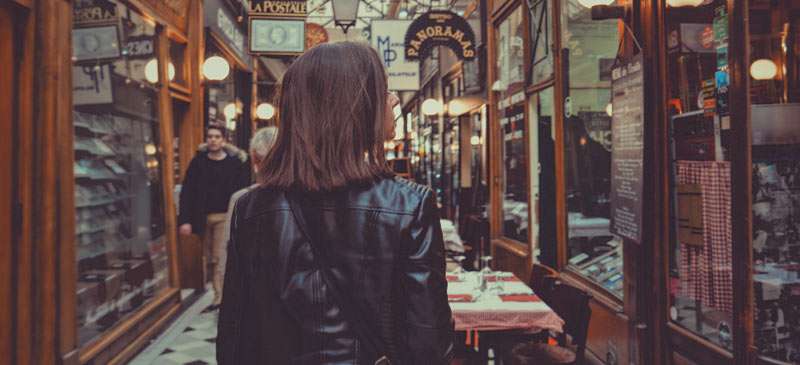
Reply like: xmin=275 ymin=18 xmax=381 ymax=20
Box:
xmin=447 ymin=271 xmax=564 ymax=333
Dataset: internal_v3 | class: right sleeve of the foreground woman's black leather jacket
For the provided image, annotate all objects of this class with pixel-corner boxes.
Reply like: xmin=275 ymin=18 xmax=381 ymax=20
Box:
xmin=399 ymin=189 xmax=454 ymax=364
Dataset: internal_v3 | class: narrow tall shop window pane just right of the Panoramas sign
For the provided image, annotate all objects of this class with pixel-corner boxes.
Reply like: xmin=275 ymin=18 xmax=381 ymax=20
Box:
xmin=492 ymin=7 xmax=529 ymax=242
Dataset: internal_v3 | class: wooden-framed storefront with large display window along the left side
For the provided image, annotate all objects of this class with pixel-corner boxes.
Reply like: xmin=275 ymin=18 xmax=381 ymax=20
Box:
xmin=0 ymin=0 xmax=203 ymax=364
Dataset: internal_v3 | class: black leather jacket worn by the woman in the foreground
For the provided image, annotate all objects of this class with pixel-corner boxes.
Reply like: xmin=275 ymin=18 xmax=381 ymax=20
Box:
xmin=217 ymin=178 xmax=453 ymax=365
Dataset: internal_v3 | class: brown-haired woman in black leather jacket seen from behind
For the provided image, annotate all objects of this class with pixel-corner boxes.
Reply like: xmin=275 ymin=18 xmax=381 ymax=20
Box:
xmin=217 ymin=42 xmax=453 ymax=365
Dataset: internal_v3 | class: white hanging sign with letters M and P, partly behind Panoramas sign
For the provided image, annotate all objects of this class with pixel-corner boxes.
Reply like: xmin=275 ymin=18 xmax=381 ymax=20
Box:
xmin=372 ymin=19 xmax=419 ymax=91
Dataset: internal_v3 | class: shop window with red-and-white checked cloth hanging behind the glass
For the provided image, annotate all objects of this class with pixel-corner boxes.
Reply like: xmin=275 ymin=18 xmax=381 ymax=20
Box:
xmin=665 ymin=0 xmax=734 ymax=350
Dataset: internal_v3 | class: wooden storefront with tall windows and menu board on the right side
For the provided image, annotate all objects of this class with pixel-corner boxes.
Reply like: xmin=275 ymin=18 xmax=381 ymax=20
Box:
xmin=489 ymin=0 xmax=800 ymax=364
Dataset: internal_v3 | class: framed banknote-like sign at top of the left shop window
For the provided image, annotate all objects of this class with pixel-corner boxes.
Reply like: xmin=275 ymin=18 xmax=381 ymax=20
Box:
xmin=72 ymin=25 xmax=120 ymax=62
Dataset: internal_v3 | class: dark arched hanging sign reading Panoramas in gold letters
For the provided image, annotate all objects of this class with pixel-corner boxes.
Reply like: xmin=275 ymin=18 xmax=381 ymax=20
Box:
xmin=405 ymin=10 xmax=476 ymax=60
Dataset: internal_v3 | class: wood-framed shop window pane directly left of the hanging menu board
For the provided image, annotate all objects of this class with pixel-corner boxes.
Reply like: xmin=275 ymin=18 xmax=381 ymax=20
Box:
xmin=561 ymin=0 xmax=623 ymax=298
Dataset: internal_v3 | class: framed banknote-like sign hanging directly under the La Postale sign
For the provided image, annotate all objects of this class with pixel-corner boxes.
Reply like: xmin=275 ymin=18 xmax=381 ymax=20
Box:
xmin=250 ymin=18 xmax=306 ymax=54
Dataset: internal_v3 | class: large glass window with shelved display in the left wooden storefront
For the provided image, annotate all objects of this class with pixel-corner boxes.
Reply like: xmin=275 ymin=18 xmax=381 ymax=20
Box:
xmin=72 ymin=2 xmax=169 ymax=345
